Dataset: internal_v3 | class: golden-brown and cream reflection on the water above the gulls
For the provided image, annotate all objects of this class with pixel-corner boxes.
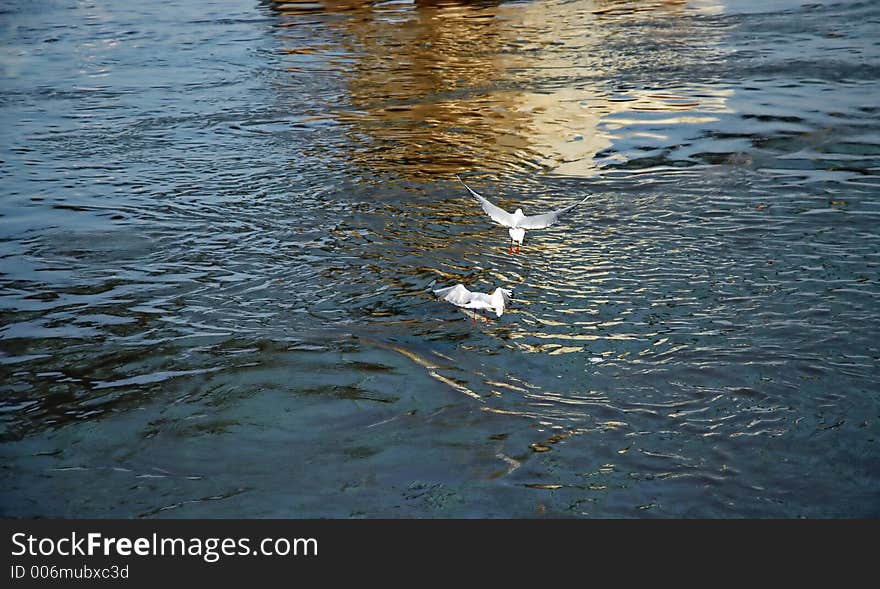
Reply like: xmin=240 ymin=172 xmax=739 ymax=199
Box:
xmin=273 ymin=0 xmax=729 ymax=178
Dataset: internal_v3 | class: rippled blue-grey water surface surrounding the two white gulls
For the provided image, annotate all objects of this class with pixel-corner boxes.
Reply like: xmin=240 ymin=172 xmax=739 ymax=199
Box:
xmin=0 ymin=0 xmax=880 ymax=517
